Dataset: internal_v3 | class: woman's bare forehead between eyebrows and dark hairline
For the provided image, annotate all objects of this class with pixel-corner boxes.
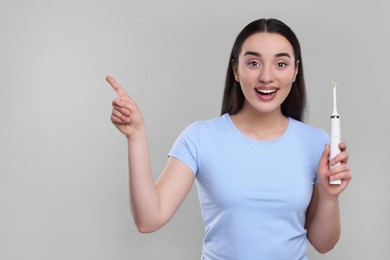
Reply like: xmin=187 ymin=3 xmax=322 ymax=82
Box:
xmin=240 ymin=32 xmax=294 ymax=57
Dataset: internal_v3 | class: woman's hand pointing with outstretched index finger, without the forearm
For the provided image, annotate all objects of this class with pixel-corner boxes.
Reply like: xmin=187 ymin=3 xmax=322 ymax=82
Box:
xmin=106 ymin=76 xmax=144 ymax=138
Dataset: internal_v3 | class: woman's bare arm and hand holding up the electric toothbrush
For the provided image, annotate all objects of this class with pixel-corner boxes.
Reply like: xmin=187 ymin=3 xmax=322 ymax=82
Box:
xmin=306 ymin=143 xmax=352 ymax=253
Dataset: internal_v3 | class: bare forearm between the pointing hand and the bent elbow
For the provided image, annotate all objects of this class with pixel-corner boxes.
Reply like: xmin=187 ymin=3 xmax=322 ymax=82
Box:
xmin=127 ymin=131 xmax=160 ymax=232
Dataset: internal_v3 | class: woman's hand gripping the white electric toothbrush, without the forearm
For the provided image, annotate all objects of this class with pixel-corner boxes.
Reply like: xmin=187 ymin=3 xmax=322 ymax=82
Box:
xmin=318 ymin=142 xmax=352 ymax=197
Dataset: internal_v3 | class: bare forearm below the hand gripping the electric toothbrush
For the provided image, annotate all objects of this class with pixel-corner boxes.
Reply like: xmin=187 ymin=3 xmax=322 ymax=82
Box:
xmin=308 ymin=197 xmax=341 ymax=253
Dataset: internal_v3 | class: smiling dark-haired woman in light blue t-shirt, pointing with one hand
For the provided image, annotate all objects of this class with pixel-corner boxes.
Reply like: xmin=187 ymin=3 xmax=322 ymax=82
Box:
xmin=107 ymin=19 xmax=352 ymax=260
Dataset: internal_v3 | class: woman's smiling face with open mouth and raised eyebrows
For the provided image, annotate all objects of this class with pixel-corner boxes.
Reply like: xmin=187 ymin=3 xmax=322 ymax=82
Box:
xmin=234 ymin=33 xmax=298 ymax=113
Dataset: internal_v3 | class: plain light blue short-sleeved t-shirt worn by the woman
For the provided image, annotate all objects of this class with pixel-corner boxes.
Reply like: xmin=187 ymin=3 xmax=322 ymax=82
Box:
xmin=169 ymin=114 xmax=329 ymax=260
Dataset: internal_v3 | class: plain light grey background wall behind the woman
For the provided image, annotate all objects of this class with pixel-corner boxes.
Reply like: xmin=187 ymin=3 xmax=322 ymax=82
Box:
xmin=0 ymin=0 xmax=390 ymax=260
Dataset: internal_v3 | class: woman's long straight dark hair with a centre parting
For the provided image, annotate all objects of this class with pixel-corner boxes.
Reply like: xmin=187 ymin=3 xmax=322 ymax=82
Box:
xmin=221 ymin=19 xmax=306 ymax=121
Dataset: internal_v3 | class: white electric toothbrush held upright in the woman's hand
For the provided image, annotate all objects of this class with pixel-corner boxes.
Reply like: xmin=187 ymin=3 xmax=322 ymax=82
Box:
xmin=329 ymin=80 xmax=341 ymax=185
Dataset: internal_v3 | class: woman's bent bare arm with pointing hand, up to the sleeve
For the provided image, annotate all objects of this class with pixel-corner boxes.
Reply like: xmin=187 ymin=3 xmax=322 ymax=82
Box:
xmin=106 ymin=76 xmax=195 ymax=233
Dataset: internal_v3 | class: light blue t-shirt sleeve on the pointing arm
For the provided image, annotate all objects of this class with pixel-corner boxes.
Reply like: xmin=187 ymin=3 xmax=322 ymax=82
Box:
xmin=168 ymin=123 xmax=199 ymax=174
